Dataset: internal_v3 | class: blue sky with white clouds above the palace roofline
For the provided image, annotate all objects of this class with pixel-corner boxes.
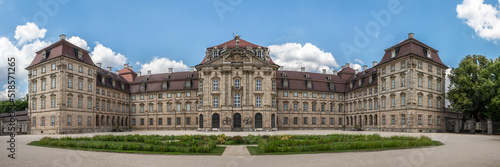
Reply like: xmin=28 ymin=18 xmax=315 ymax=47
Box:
xmin=0 ymin=0 xmax=500 ymax=100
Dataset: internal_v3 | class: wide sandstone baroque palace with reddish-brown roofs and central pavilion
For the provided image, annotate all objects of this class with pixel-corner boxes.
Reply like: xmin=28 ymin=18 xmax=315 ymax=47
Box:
xmin=26 ymin=33 xmax=448 ymax=134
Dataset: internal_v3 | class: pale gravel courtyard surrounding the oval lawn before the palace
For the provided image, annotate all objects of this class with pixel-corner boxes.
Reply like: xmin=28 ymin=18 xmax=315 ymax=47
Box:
xmin=0 ymin=130 xmax=500 ymax=166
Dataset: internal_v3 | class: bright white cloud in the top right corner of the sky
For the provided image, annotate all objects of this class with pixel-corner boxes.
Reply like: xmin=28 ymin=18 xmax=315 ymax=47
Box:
xmin=456 ymin=0 xmax=500 ymax=40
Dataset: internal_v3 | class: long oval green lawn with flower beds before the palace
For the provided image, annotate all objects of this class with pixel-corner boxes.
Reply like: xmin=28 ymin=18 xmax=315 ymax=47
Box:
xmin=29 ymin=134 xmax=442 ymax=155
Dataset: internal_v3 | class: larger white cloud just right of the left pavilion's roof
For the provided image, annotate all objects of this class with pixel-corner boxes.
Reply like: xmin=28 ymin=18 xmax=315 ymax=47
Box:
xmin=90 ymin=42 xmax=127 ymax=69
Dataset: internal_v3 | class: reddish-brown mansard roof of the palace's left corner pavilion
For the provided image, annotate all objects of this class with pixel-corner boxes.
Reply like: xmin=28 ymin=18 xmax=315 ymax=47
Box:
xmin=26 ymin=39 xmax=96 ymax=69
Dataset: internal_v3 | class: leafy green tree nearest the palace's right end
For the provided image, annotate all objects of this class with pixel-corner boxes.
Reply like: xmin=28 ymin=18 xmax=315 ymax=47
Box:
xmin=447 ymin=55 xmax=489 ymax=133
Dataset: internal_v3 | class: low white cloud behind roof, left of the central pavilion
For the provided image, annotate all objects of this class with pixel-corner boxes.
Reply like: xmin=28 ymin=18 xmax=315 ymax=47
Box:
xmin=141 ymin=57 xmax=189 ymax=74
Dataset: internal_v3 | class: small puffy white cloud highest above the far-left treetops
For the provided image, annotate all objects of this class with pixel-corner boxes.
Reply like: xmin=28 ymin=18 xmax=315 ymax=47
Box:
xmin=14 ymin=22 xmax=47 ymax=46
